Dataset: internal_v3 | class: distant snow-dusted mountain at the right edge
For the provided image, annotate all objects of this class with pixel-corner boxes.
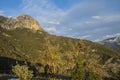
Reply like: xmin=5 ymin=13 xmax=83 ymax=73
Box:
xmin=100 ymin=35 xmax=120 ymax=53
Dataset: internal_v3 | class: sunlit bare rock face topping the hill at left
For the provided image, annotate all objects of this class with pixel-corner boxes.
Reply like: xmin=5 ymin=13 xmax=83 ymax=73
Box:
xmin=0 ymin=14 xmax=44 ymax=31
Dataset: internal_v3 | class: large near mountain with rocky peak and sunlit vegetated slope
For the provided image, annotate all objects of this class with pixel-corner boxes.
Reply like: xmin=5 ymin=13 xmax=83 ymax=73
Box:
xmin=0 ymin=15 xmax=120 ymax=80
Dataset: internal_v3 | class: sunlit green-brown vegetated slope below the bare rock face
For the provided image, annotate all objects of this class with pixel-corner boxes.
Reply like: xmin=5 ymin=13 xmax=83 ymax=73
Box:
xmin=0 ymin=14 xmax=120 ymax=79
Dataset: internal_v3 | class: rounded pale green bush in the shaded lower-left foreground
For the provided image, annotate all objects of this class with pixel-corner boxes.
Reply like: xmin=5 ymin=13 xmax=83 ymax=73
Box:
xmin=12 ymin=64 xmax=33 ymax=80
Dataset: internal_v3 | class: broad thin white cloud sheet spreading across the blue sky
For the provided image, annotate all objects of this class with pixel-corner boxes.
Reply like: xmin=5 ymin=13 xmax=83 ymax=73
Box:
xmin=20 ymin=0 xmax=120 ymax=40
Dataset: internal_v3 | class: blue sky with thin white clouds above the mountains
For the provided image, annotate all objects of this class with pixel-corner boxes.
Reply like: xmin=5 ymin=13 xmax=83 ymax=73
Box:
xmin=0 ymin=0 xmax=120 ymax=41
